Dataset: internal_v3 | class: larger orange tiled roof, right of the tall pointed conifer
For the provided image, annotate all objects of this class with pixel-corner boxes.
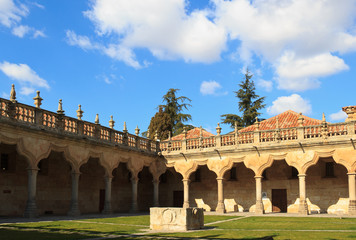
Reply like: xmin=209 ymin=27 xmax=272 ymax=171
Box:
xmin=239 ymin=110 xmax=322 ymax=132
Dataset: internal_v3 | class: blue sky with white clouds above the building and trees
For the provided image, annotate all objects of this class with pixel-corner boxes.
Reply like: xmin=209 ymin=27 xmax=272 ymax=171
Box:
xmin=0 ymin=0 xmax=356 ymax=133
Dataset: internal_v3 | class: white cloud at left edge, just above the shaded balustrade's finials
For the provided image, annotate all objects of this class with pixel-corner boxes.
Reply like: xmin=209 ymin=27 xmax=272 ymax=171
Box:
xmin=0 ymin=62 xmax=50 ymax=95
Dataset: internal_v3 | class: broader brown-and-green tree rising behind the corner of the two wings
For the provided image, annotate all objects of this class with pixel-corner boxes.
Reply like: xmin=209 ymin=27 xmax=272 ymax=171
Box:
xmin=148 ymin=88 xmax=194 ymax=140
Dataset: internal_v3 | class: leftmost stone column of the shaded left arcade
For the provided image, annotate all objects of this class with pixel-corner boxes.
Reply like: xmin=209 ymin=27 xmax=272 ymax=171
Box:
xmin=24 ymin=168 xmax=38 ymax=218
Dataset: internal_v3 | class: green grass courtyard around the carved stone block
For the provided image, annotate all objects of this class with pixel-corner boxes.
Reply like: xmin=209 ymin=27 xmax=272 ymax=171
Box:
xmin=0 ymin=215 xmax=356 ymax=240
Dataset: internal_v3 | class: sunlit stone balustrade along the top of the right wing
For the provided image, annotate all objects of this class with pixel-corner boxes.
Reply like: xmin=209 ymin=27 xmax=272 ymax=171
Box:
xmin=160 ymin=121 xmax=356 ymax=154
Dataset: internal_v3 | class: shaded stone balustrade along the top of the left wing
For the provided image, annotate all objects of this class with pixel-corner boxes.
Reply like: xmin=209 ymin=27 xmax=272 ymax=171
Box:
xmin=0 ymin=98 xmax=160 ymax=154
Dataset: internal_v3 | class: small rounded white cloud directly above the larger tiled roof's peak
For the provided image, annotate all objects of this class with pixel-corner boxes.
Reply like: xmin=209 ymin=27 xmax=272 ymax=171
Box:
xmin=267 ymin=94 xmax=312 ymax=115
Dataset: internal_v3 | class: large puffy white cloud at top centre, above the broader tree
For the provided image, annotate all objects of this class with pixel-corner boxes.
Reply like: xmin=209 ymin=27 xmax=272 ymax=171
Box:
xmin=67 ymin=0 xmax=226 ymax=68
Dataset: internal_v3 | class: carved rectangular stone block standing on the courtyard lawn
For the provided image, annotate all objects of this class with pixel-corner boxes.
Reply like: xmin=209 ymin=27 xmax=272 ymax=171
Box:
xmin=150 ymin=208 xmax=204 ymax=231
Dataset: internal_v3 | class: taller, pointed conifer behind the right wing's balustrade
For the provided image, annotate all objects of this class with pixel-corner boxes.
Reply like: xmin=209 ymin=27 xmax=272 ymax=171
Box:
xmin=221 ymin=69 xmax=266 ymax=128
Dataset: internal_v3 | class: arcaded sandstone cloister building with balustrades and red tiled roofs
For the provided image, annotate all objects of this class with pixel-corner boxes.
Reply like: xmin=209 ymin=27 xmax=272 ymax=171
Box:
xmin=0 ymin=87 xmax=356 ymax=217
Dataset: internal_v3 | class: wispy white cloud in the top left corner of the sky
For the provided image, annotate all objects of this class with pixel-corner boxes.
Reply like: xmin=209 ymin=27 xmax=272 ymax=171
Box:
xmin=0 ymin=0 xmax=45 ymax=38
